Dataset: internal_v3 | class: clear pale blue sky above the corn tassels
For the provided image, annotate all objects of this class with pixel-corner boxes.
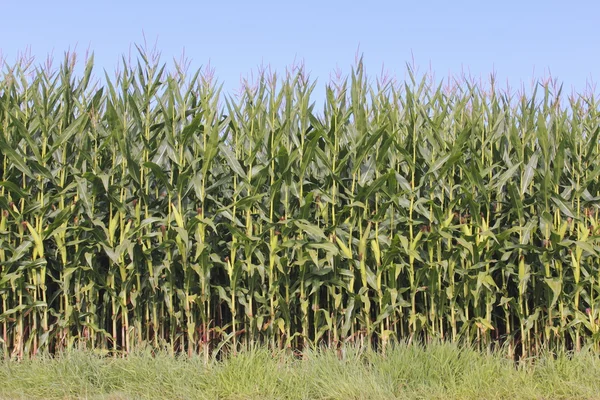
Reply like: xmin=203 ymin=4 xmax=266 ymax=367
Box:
xmin=0 ymin=0 xmax=600 ymax=103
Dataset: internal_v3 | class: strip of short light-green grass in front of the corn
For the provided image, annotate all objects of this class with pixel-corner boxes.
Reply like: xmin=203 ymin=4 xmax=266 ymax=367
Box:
xmin=0 ymin=344 xmax=600 ymax=399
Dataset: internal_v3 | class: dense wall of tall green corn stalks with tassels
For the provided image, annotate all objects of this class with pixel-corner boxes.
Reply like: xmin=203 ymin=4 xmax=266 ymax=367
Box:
xmin=0 ymin=51 xmax=600 ymax=358
